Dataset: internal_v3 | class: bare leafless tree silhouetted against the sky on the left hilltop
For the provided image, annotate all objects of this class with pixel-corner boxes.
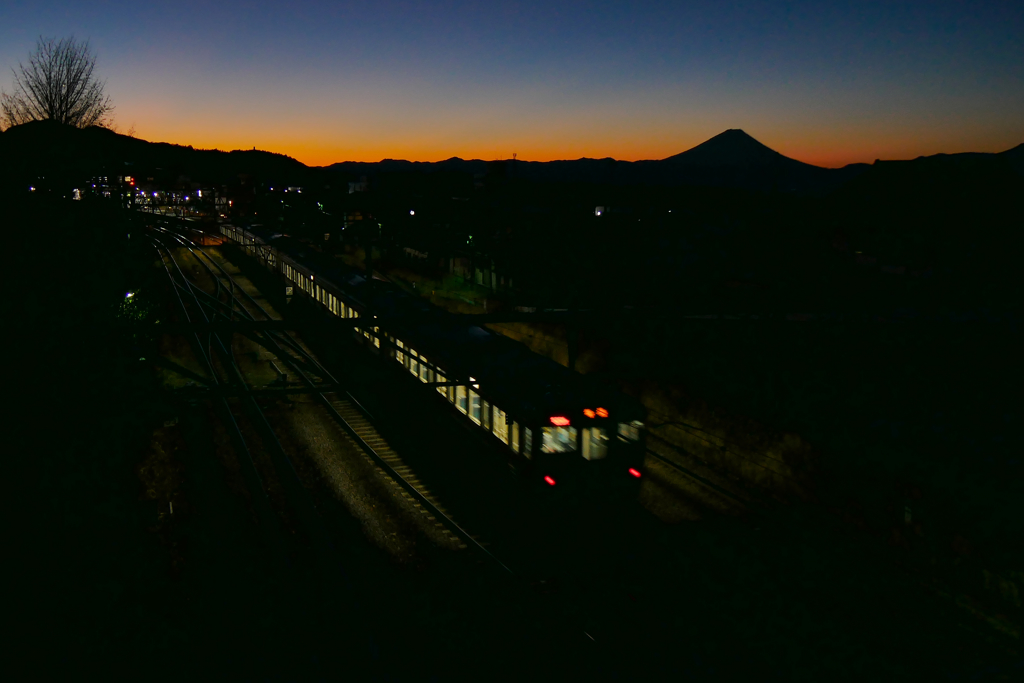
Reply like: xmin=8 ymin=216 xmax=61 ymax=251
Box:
xmin=0 ymin=36 xmax=114 ymax=128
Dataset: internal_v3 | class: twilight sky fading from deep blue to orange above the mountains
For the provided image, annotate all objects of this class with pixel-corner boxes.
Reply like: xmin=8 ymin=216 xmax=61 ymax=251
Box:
xmin=0 ymin=0 xmax=1024 ymax=166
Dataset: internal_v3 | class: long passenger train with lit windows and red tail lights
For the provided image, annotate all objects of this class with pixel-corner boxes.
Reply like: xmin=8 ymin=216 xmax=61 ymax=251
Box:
xmin=219 ymin=223 xmax=646 ymax=493
